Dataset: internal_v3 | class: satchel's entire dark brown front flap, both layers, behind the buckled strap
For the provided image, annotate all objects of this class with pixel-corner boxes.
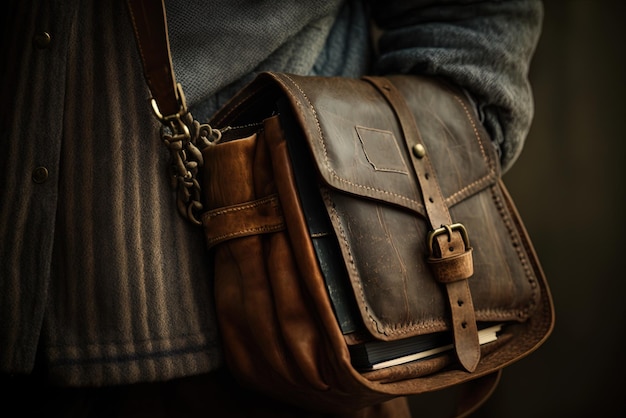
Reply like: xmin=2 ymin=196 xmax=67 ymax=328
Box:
xmin=211 ymin=73 xmax=541 ymax=340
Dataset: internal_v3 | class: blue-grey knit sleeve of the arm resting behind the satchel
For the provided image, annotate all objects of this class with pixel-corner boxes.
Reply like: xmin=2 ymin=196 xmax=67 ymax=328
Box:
xmin=372 ymin=0 xmax=543 ymax=171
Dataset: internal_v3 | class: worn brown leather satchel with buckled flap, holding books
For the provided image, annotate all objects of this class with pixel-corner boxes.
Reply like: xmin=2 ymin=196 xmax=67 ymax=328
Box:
xmin=201 ymin=73 xmax=554 ymax=411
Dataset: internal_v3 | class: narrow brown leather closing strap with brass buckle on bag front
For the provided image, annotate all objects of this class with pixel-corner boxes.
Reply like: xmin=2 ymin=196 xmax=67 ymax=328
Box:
xmin=365 ymin=77 xmax=480 ymax=372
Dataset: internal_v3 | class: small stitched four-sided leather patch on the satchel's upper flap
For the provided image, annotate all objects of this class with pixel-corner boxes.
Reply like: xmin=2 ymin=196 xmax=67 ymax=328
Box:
xmin=356 ymin=125 xmax=408 ymax=174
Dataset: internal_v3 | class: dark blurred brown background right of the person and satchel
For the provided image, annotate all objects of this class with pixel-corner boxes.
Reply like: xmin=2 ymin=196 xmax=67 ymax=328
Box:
xmin=408 ymin=0 xmax=626 ymax=418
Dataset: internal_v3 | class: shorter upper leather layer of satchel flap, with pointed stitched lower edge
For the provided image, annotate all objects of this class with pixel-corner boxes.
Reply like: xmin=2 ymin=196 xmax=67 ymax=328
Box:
xmin=272 ymin=75 xmax=498 ymax=215
